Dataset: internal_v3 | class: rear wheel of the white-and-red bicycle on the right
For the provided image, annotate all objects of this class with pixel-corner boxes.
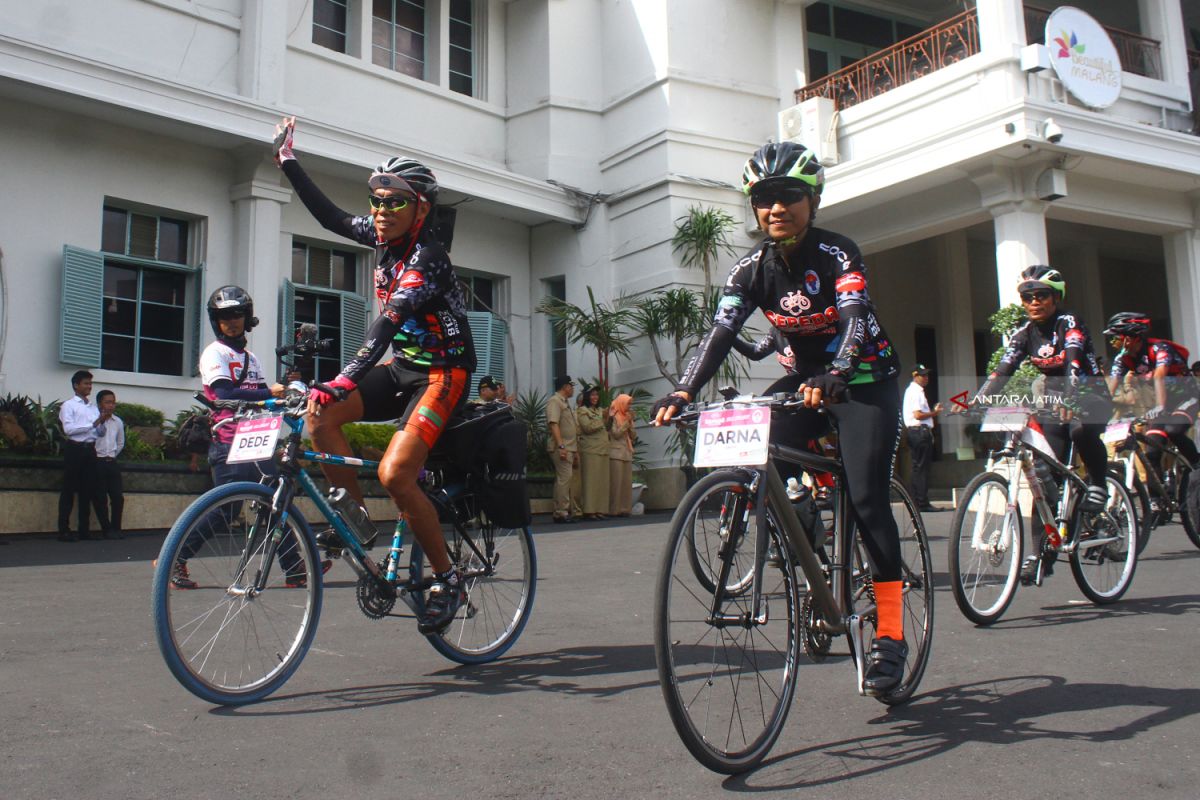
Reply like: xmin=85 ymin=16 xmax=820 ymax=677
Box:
xmin=1070 ymin=475 xmax=1138 ymax=606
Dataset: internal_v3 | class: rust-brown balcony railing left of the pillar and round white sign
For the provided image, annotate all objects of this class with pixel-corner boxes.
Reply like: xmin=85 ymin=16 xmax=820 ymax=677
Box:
xmin=796 ymin=8 xmax=979 ymax=109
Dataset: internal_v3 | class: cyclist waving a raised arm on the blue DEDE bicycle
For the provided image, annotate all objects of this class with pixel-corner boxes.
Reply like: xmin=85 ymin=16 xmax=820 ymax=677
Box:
xmin=275 ymin=118 xmax=475 ymax=633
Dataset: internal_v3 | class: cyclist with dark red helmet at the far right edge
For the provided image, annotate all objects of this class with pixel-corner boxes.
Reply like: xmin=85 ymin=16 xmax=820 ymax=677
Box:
xmin=1104 ymin=311 xmax=1200 ymax=469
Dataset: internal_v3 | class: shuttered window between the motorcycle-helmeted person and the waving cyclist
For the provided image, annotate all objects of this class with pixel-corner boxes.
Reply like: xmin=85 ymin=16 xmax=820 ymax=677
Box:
xmin=280 ymin=239 xmax=367 ymax=381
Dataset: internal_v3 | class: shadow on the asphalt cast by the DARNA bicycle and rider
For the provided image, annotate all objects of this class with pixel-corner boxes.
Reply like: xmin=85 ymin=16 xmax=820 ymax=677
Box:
xmin=722 ymin=675 xmax=1200 ymax=792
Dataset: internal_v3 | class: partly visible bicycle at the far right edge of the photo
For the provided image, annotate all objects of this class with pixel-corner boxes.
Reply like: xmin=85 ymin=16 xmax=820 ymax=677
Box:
xmin=1105 ymin=417 xmax=1200 ymax=555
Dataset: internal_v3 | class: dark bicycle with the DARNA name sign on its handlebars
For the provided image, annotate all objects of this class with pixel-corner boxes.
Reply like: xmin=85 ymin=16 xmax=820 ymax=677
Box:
xmin=654 ymin=395 xmax=934 ymax=774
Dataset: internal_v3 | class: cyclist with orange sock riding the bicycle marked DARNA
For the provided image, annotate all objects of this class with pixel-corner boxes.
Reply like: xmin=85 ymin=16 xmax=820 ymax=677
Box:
xmin=655 ymin=142 xmax=907 ymax=694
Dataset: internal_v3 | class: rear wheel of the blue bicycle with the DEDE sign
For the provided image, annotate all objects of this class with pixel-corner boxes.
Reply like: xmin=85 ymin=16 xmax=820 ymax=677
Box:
xmin=408 ymin=525 xmax=538 ymax=664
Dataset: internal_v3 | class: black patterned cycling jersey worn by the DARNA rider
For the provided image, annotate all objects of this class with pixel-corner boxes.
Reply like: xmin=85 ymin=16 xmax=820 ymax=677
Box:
xmin=677 ymin=228 xmax=900 ymax=395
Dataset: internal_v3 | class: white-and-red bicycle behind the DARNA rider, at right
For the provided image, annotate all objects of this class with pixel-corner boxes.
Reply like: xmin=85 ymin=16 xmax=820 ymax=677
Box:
xmin=949 ymin=409 xmax=1138 ymax=625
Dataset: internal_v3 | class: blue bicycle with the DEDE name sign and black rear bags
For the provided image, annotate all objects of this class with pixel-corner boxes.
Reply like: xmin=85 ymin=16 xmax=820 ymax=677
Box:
xmin=152 ymin=392 xmax=538 ymax=705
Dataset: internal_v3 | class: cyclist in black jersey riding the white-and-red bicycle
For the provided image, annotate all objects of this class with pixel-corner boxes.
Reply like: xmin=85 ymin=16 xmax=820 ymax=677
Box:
xmin=973 ymin=264 xmax=1112 ymax=579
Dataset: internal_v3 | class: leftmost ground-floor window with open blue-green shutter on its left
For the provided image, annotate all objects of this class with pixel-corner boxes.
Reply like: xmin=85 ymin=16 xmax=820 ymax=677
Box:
xmin=60 ymin=203 xmax=202 ymax=375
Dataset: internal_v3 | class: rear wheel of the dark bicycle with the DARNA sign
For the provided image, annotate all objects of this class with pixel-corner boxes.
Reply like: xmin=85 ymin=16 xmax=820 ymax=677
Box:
xmin=846 ymin=477 xmax=934 ymax=705
